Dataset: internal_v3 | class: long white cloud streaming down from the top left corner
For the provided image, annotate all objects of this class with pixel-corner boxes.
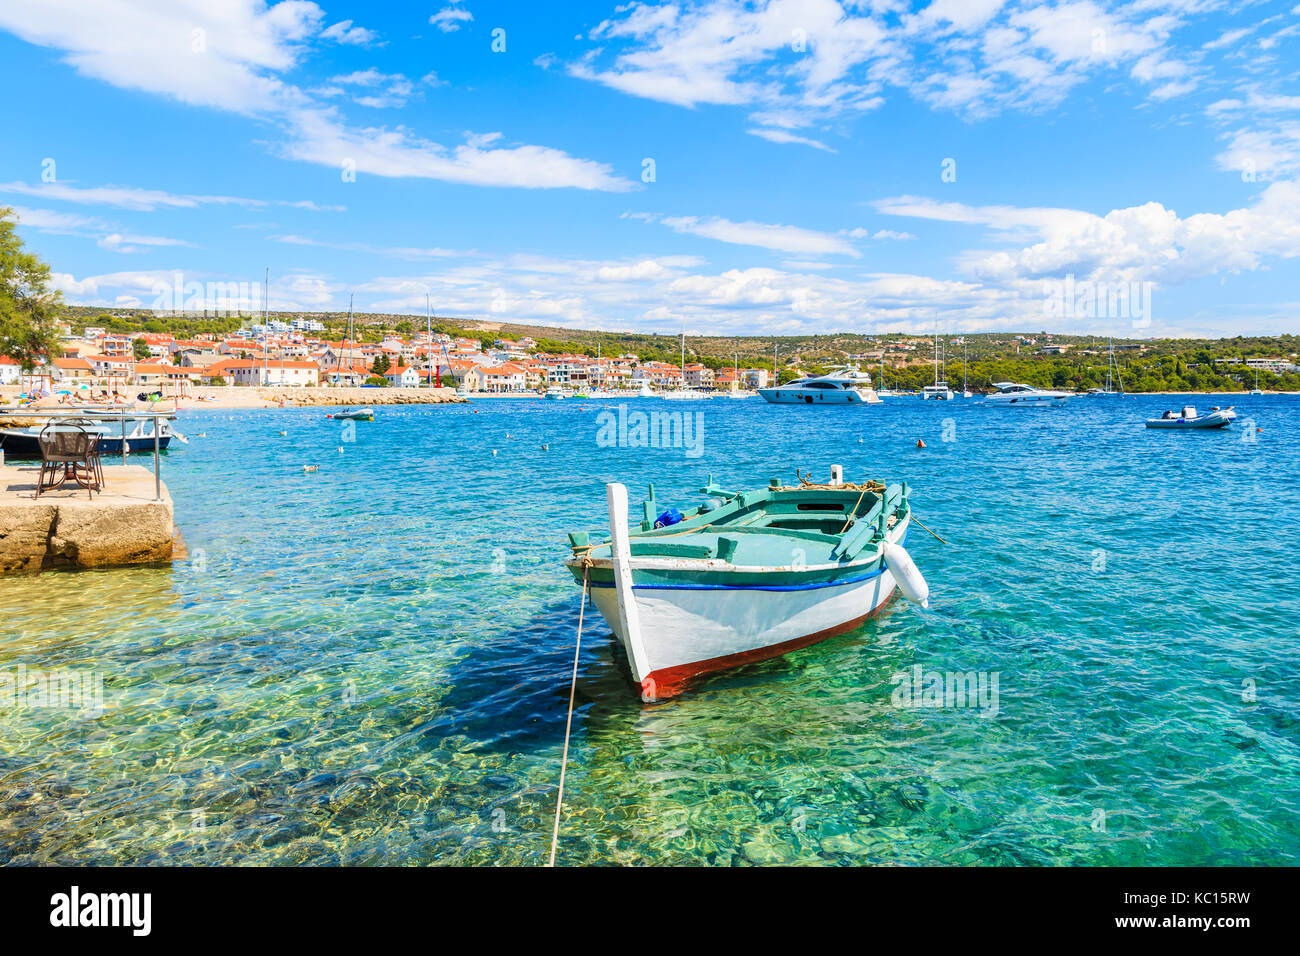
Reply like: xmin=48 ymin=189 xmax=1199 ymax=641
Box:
xmin=0 ymin=0 xmax=633 ymax=191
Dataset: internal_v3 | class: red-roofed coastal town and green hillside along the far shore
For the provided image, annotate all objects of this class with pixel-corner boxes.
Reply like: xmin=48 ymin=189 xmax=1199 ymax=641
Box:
xmin=0 ymin=313 xmax=1300 ymax=398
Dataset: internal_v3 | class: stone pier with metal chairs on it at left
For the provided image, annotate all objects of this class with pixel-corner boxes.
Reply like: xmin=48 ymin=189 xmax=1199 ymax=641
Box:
xmin=0 ymin=464 xmax=182 ymax=575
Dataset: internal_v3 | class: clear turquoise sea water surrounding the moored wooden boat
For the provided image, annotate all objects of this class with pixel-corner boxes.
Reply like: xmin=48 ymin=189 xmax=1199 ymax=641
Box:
xmin=0 ymin=395 xmax=1300 ymax=865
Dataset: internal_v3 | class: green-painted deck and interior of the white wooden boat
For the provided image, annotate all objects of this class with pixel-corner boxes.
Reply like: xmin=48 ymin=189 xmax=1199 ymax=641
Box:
xmin=569 ymin=476 xmax=909 ymax=566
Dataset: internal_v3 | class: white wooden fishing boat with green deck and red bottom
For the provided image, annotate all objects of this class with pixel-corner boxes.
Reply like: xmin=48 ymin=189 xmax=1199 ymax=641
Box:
xmin=566 ymin=466 xmax=928 ymax=700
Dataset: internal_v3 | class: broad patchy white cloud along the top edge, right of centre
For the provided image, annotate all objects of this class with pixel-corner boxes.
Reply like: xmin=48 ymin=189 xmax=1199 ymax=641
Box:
xmin=568 ymin=0 xmax=1197 ymax=123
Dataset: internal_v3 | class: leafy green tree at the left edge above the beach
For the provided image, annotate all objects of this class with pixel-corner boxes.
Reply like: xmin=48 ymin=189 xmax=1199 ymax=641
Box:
xmin=0 ymin=207 xmax=62 ymax=372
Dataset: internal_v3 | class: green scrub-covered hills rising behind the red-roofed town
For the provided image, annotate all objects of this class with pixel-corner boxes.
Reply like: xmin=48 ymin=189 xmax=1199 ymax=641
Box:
xmin=64 ymin=306 xmax=1300 ymax=392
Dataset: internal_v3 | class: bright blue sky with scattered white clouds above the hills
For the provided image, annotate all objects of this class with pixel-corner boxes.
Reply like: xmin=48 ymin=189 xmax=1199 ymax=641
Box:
xmin=0 ymin=0 xmax=1300 ymax=336
